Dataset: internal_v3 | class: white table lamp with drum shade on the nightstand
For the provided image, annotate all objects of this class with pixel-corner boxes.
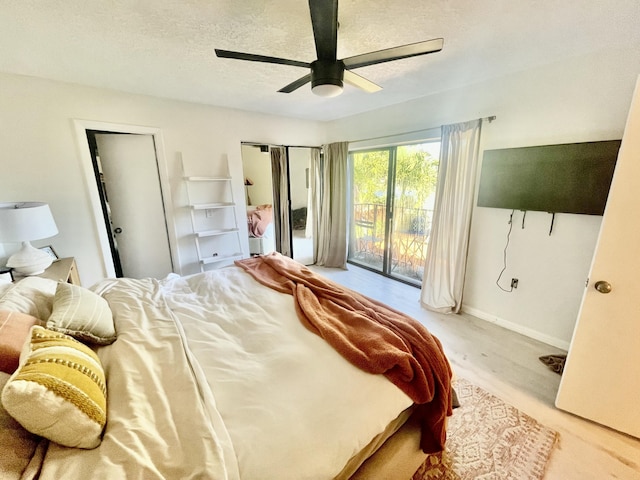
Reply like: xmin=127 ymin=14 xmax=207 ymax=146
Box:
xmin=0 ymin=202 xmax=58 ymax=275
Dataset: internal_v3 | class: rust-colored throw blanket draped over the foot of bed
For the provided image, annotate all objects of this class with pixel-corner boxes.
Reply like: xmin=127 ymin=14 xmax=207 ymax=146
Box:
xmin=235 ymin=252 xmax=452 ymax=453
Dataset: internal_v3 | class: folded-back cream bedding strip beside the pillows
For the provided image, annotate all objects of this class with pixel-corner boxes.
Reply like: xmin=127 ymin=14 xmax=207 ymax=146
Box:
xmin=35 ymin=279 xmax=238 ymax=480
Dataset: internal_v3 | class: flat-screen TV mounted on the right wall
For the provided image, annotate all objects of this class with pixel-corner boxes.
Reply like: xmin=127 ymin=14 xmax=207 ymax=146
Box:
xmin=478 ymin=140 xmax=621 ymax=215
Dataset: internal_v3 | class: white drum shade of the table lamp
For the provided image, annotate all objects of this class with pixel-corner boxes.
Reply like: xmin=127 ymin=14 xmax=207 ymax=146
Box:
xmin=0 ymin=202 xmax=58 ymax=242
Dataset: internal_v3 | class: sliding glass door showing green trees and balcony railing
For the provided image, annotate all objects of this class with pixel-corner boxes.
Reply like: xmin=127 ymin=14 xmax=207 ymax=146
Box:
xmin=348 ymin=142 xmax=440 ymax=285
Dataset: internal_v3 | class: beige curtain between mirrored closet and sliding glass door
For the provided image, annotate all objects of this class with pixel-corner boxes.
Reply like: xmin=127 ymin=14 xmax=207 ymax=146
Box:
xmin=313 ymin=142 xmax=349 ymax=268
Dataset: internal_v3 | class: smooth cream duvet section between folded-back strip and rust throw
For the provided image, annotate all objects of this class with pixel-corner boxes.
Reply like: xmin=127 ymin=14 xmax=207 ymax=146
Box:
xmin=162 ymin=266 xmax=411 ymax=480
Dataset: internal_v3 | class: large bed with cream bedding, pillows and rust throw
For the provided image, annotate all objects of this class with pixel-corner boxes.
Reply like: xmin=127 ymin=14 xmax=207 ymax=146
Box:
xmin=0 ymin=253 xmax=452 ymax=480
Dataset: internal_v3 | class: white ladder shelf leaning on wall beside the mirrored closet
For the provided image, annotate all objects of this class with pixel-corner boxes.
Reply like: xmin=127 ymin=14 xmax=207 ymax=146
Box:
xmin=182 ymin=158 xmax=243 ymax=272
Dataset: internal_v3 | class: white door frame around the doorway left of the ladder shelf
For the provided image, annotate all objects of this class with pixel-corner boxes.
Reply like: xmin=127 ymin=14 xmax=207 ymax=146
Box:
xmin=73 ymin=119 xmax=181 ymax=278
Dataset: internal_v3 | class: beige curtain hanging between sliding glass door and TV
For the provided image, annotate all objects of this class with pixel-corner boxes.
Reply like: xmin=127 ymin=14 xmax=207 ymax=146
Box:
xmin=420 ymin=120 xmax=482 ymax=313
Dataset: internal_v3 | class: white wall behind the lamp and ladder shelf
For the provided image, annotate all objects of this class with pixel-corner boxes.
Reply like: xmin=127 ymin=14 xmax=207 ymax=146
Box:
xmin=0 ymin=74 xmax=323 ymax=285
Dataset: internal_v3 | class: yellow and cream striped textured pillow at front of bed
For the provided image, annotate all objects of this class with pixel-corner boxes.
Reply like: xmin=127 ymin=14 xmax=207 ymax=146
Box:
xmin=2 ymin=326 xmax=107 ymax=448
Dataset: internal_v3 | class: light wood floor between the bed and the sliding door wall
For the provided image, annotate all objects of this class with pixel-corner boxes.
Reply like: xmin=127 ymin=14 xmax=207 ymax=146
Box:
xmin=311 ymin=265 xmax=640 ymax=480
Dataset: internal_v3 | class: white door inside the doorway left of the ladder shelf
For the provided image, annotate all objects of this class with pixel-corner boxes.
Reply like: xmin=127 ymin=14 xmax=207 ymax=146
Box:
xmin=95 ymin=134 xmax=172 ymax=278
